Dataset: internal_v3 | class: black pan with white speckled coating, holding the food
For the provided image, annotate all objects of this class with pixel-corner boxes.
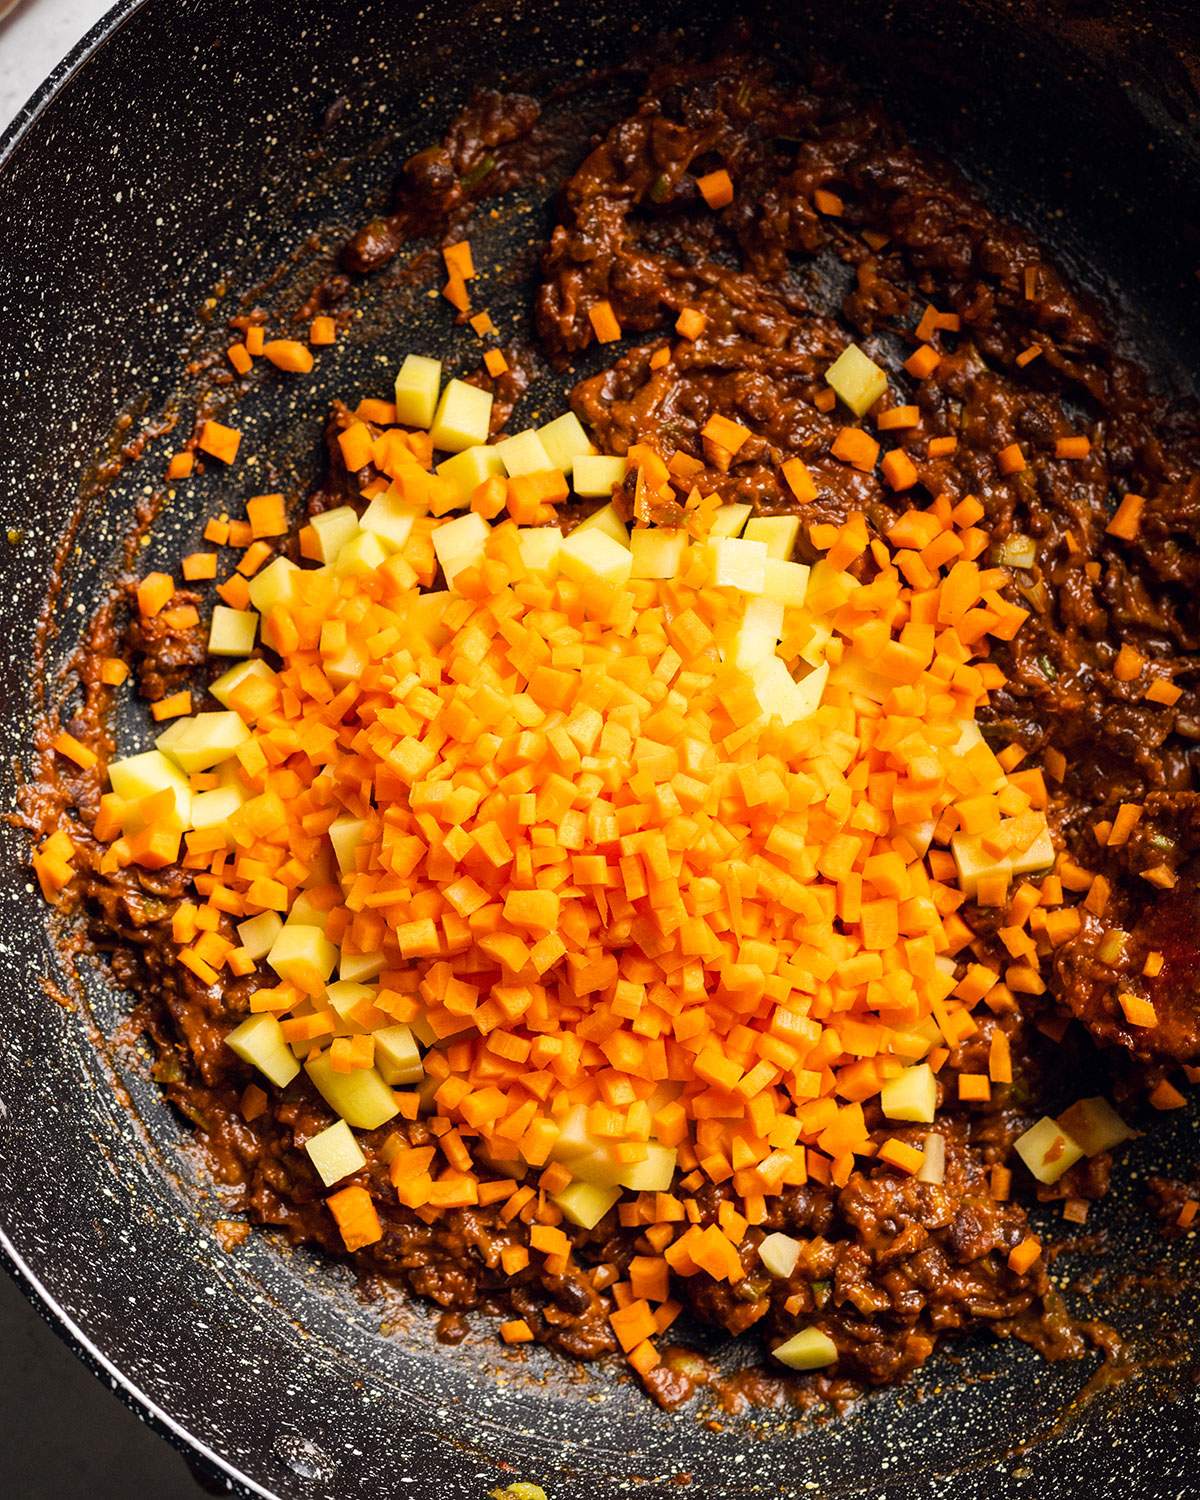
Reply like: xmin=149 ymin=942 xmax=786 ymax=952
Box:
xmin=0 ymin=0 xmax=1200 ymax=1500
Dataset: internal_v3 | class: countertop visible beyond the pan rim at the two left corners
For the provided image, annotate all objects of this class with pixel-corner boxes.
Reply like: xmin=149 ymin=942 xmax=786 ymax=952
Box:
xmin=0 ymin=14 xmax=209 ymax=1500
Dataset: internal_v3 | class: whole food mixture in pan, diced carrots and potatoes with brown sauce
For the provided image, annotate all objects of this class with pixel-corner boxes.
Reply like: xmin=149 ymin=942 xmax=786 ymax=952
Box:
xmin=35 ymin=49 xmax=1197 ymax=1404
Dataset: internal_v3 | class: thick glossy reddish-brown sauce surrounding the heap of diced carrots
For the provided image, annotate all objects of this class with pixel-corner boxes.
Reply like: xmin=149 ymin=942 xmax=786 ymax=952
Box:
xmin=26 ymin=46 xmax=1200 ymax=1406
